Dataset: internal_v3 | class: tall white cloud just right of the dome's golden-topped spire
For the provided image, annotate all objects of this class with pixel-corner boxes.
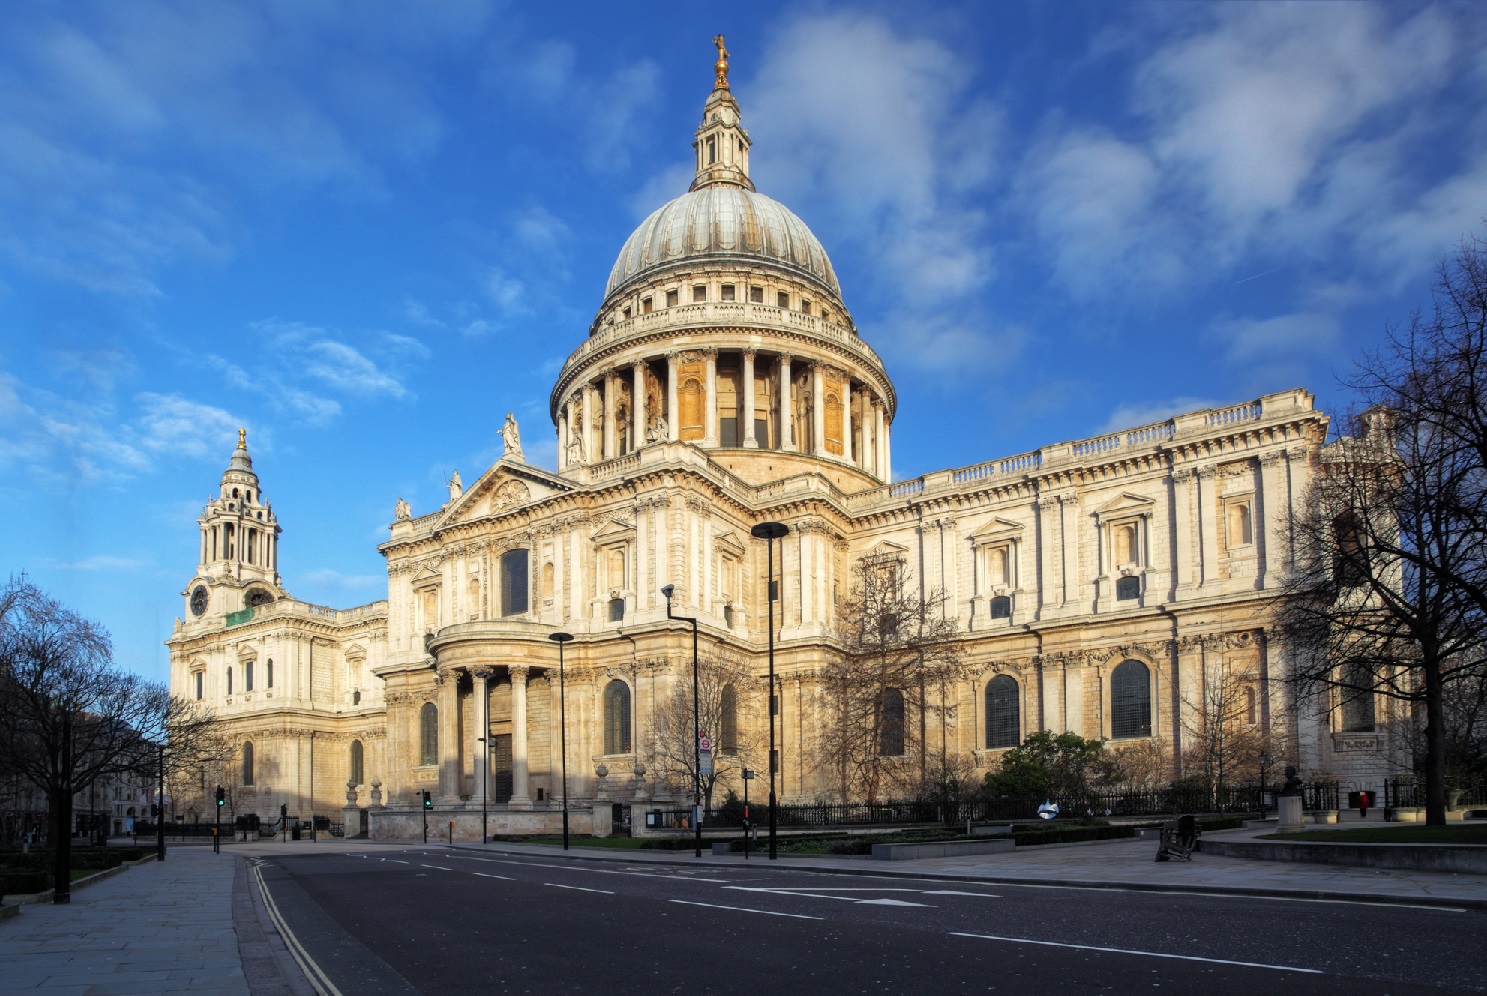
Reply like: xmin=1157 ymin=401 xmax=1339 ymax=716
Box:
xmin=749 ymin=13 xmax=1005 ymax=367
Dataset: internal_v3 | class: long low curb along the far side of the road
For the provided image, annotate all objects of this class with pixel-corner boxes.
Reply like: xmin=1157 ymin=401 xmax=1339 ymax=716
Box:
xmin=439 ymin=844 xmax=1487 ymax=911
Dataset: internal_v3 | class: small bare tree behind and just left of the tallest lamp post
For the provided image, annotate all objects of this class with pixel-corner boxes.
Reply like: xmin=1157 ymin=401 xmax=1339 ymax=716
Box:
xmin=650 ymin=656 xmax=764 ymax=812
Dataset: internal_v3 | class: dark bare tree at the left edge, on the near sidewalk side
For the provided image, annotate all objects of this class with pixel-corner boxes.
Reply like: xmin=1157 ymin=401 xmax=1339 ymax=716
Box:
xmin=0 ymin=577 xmax=170 ymax=902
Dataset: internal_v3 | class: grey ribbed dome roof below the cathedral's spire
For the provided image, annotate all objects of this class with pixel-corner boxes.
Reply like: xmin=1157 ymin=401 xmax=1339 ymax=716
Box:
xmin=604 ymin=184 xmax=842 ymax=297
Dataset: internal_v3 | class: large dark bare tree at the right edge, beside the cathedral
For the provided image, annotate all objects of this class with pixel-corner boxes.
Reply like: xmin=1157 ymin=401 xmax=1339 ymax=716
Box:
xmin=1279 ymin=239 xmax=1487 ymax=824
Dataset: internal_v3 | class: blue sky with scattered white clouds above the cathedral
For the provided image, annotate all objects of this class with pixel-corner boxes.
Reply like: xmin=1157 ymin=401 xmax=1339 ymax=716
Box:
xmin=0 ymin=0 xmax=1487 ymax=681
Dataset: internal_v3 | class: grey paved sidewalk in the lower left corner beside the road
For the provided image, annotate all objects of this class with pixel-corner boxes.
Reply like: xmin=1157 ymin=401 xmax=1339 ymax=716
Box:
xmin=0 ymin=847 xmax=248 ymax=996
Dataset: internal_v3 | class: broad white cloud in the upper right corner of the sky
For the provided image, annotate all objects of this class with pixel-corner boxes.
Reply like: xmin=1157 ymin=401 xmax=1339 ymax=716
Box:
xmin=1014 ymin=3 xmax=1487 ymax=299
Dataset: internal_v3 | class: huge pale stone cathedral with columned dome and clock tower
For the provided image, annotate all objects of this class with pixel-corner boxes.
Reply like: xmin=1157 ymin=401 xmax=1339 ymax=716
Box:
xmin=168 ymin=46 xmax=1407 ymax=835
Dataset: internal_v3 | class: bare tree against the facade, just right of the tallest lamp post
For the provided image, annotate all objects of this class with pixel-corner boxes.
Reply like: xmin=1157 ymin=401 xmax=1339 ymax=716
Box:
xmin=816 ymin=560 xmax=962 ymax=801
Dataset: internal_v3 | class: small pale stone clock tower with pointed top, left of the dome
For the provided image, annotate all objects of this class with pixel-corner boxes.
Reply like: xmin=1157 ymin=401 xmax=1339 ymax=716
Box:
xmin=184 ymin=428 xmax=284 ymax=620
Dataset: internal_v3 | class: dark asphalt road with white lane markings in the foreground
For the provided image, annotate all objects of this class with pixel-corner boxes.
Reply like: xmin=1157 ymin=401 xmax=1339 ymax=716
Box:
xmin=259 ymin=846 xmax=1487 ymax=996
